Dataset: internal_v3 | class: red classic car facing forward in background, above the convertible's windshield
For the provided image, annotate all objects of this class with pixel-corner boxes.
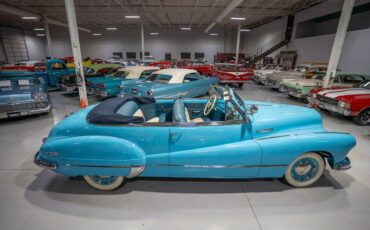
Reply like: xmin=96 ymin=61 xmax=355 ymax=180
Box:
xmin=207 ymin=63 xmax=253 ymax=87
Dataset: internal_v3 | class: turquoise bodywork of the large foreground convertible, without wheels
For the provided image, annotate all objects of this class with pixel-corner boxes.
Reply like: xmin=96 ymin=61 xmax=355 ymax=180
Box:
xmin=35 ymin=89 xmax=356 ymax=179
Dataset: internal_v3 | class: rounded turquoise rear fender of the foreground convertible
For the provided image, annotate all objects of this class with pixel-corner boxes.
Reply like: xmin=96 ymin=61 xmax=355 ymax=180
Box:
xmin=38 ymin=136 xmax=146 ymax=176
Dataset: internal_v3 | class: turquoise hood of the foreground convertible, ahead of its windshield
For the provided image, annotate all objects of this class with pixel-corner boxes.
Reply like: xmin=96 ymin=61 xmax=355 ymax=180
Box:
xmin=246 ymin=102 xmax=324 ymax=138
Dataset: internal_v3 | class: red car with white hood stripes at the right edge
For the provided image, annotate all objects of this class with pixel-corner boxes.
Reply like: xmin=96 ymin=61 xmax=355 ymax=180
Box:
xmin=309 ymin=80 xmax=370 ymax=125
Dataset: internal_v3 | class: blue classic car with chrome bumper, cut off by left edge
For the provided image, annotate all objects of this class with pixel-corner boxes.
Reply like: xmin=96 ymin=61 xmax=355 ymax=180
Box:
xmin=0 ymin=74 xmax=50 ymax=119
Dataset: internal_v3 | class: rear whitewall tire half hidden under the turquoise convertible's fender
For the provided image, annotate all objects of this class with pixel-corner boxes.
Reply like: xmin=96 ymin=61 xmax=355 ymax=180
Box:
xmin=83 ymin=176 xmax=125 ymax=191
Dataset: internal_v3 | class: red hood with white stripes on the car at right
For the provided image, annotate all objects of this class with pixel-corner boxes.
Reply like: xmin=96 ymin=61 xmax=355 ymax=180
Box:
xmin=317 ymin=88 xmax=370 ymax=99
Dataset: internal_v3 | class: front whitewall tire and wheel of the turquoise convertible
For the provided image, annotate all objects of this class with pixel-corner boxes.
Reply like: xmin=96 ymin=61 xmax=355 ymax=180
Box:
xmin=284 ymin=153 xmax=325 ymax=187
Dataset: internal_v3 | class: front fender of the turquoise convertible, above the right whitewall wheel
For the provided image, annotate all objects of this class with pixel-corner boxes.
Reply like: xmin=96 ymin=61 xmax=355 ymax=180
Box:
xmin=255 ymin=132 xmax=356 ymax=177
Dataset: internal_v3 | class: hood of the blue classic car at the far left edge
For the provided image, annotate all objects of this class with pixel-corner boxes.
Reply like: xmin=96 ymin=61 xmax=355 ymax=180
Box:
xmin=0 ymin=85 xmax=44 ymax=104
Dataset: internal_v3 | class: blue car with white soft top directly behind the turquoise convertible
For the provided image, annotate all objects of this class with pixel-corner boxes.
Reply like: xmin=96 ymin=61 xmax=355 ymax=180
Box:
xmin=118 ymin=69 xmax=219 ymax=98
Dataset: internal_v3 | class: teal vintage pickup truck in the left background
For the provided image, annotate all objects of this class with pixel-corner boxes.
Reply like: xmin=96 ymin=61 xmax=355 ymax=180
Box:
xmin=0 ymin=59 xmax=75 ymax=89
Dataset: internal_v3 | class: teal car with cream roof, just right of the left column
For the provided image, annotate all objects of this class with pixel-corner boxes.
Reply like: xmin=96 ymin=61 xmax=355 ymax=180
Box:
xmin=86 ymin=66 xmax=159 ymax=98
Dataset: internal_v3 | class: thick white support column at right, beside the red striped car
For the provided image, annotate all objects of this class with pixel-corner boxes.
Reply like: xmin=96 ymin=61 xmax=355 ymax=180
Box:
xmin=323 ymin=0 xmax=355 ymax=88
